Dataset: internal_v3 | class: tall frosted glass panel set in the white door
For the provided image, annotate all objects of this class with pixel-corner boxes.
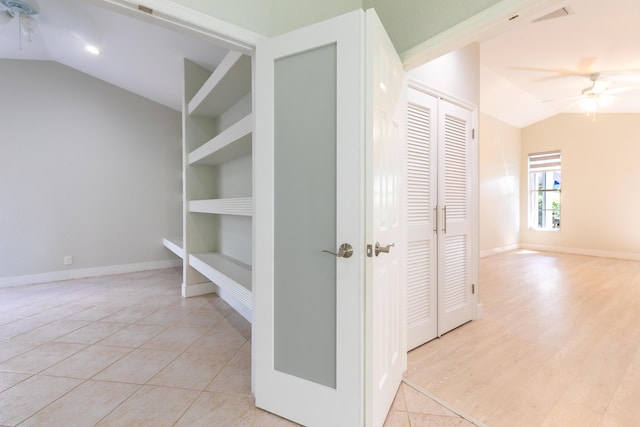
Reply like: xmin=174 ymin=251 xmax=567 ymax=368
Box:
xmin=274 ymin=44 xmax=339 ymax=388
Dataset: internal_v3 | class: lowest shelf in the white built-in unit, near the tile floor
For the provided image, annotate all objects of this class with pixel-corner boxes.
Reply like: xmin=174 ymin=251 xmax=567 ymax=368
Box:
xmin=189 ymin=252 xmax=253 ymax=321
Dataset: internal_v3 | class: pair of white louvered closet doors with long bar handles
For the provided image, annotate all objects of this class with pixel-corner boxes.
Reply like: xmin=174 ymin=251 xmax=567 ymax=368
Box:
xmin=407 ymin=88 xmax=476 ymax=349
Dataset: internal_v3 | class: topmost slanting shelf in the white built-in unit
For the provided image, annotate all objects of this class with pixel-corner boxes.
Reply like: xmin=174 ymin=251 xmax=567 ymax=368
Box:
xmin=187 ymin=51 xmax=251 ymax=117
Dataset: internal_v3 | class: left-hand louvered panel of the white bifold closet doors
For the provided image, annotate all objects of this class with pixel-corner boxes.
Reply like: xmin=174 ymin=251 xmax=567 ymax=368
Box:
xmin=407 ymin=88 xmax=438 ymax=350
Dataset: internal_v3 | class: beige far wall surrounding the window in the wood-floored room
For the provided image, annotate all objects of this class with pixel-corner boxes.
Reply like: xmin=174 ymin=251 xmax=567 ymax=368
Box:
xmin=520 ymin=114 xmax=640 ymax=260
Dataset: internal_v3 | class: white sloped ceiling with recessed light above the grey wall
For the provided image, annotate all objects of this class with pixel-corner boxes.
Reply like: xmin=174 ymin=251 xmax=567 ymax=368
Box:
xmin=0 ymin=0 xmax=226 ymax=111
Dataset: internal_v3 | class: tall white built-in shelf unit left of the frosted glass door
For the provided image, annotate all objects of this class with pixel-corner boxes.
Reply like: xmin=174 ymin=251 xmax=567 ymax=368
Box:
xmin=164 ymin=51 xmax=253 ymax=321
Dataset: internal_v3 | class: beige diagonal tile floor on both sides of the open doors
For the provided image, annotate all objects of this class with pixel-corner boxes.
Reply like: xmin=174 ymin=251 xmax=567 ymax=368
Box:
xmin=0 ymin=269 xmax=473 ymax=427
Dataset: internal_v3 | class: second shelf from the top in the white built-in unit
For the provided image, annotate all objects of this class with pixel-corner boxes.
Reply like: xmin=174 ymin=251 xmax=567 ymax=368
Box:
xmin=189 ymin=114 xmax=253 ymax=165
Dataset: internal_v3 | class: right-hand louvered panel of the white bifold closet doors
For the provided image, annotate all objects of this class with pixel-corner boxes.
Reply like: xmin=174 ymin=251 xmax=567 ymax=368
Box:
xmin=438 ymin=101 xmax=473 ymax=335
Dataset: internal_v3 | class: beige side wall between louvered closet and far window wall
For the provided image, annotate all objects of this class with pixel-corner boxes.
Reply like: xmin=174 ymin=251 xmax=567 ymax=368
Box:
xmin=479 ymin=114 xmax=521 ymax=256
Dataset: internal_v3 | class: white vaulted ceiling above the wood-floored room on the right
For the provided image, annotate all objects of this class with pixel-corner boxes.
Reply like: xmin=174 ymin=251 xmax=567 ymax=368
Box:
xmin=480 ymin=0 xmax=640 ymax=127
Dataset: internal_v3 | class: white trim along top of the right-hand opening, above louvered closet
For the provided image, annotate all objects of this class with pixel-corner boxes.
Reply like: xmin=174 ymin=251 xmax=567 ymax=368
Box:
xmin=400 ymin=0 xmax=561 ymax=70
